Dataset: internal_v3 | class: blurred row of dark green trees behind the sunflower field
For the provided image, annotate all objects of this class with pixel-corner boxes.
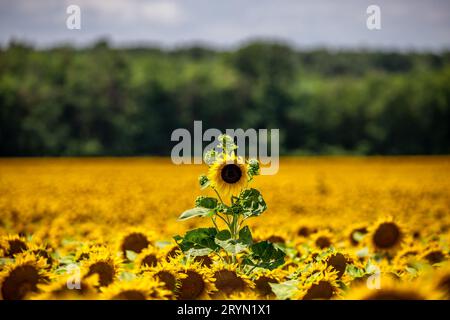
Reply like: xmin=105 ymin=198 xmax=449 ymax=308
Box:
xmin=0 ymin=42 xmax=450 ymax=156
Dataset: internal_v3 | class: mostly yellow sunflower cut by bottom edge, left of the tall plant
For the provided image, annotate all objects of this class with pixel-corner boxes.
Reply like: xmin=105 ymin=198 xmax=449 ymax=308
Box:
xmin=101 ymin=277 xmax=171 ymax=300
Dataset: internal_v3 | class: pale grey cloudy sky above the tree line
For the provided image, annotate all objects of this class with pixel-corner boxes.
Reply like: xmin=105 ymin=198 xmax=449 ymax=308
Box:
xmin=0 ymin=0 xmax=450 ymax=50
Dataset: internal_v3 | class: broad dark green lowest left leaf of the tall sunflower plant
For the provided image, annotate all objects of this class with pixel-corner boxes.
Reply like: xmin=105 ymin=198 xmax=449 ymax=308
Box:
xmin=174 ymin=228 xmax=219 ymax=255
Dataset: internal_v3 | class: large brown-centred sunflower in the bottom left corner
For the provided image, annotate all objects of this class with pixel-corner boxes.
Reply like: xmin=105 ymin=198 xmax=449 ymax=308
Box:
xmin=0 ymin=253 xmax=49 ymax=300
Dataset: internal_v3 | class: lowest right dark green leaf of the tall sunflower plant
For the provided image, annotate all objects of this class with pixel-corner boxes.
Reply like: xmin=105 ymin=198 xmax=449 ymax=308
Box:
xmin=243 ymin=241 xmax=286 ymax=270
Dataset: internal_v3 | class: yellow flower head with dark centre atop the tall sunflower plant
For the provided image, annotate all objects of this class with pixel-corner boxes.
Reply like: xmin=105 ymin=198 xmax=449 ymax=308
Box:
xmin=208 ymin=155 xmax=248 ymax=197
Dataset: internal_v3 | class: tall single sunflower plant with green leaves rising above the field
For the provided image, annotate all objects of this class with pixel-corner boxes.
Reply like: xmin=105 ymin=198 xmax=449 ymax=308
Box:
xmin=174 ymin=135 xmax=285 ymax=273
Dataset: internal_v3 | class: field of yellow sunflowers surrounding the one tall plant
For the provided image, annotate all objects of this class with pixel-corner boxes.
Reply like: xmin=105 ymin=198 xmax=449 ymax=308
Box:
xmin=0 ymin=157 xmax=450 ymax=299
